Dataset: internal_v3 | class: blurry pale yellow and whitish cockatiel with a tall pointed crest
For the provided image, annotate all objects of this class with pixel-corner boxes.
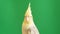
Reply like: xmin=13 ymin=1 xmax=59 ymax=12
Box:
xmin=22 ymin=3 xmax=40 ymax=34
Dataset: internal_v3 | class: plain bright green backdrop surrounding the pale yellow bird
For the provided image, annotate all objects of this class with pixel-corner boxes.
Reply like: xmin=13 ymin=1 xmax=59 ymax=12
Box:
xmin=0 ymin=0 xmax=60 ymax=34
